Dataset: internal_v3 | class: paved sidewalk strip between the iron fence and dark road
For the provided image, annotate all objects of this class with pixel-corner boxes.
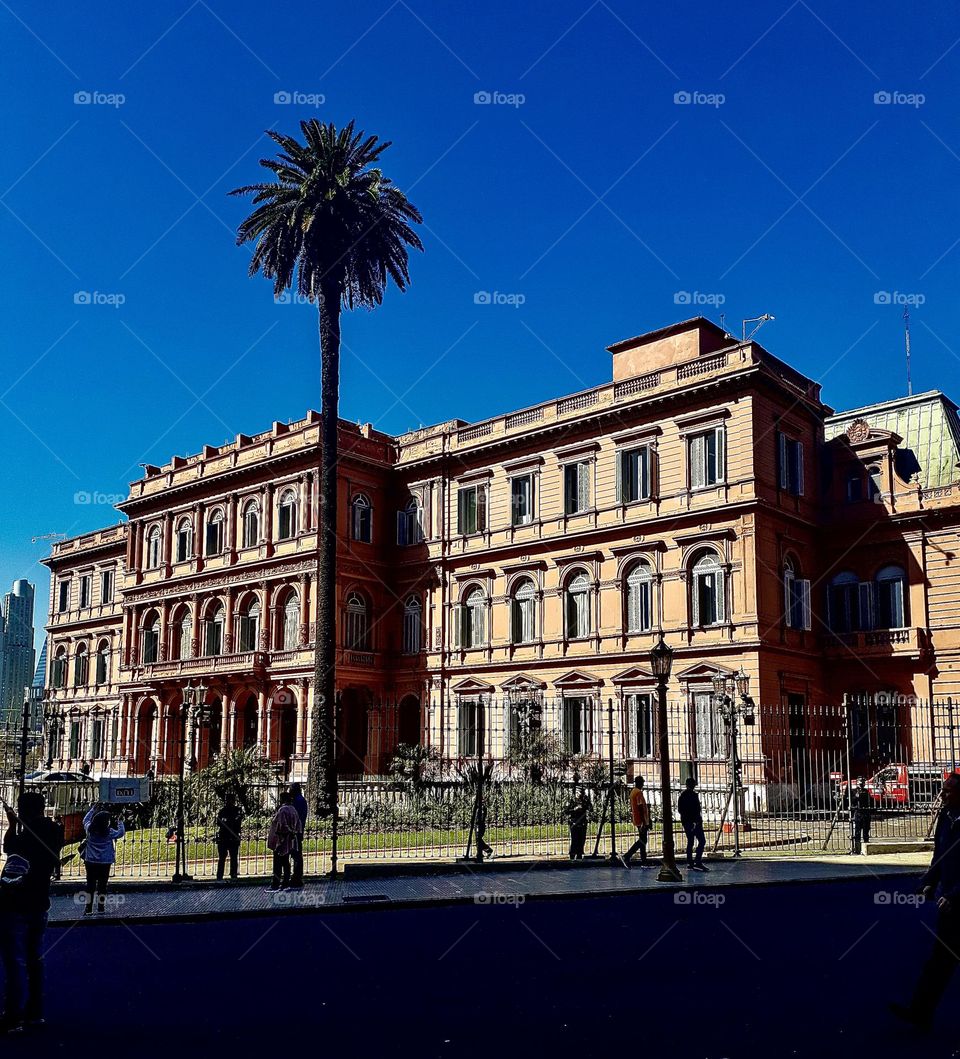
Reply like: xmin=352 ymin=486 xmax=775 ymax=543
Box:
xmin=50 ymin=852 xmax=929 ymax=927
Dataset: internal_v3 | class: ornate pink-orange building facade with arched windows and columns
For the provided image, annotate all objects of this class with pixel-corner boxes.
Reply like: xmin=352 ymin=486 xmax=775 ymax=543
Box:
xmin=41 ymin=318 xmax=960 ymax=776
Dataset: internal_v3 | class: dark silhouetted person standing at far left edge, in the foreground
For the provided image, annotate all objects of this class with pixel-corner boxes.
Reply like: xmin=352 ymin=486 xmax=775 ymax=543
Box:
xmin=0 ymin=791 xmax=64 ymax=1033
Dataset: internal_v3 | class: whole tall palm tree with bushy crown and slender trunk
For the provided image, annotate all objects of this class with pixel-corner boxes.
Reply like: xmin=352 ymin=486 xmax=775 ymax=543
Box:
xmin=231 ymin=119 xmax=423 ymax=815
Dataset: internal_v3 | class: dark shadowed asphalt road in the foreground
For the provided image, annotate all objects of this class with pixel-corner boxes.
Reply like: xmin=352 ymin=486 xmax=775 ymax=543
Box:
xmin=2 ymin=880 xmax=960 ymax=1059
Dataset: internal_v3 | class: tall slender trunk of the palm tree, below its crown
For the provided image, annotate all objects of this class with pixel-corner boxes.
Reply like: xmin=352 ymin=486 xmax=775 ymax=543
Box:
xmin=308 ymin=282 xmax=341 ymax=816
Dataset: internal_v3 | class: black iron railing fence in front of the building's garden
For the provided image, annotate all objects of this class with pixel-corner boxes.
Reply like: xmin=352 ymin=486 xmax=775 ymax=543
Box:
xmin=1 ymin=694 xmax=960 ymax=878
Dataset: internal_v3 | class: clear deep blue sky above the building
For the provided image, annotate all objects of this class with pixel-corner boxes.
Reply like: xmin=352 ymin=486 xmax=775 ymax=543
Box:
xmin=0 ymin=0 xmax=960 ymax=648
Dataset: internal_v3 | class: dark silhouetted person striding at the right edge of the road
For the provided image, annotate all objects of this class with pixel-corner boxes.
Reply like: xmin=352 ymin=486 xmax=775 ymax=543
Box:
xmin=889 ymin=772 xmax=960 ymax=1030
